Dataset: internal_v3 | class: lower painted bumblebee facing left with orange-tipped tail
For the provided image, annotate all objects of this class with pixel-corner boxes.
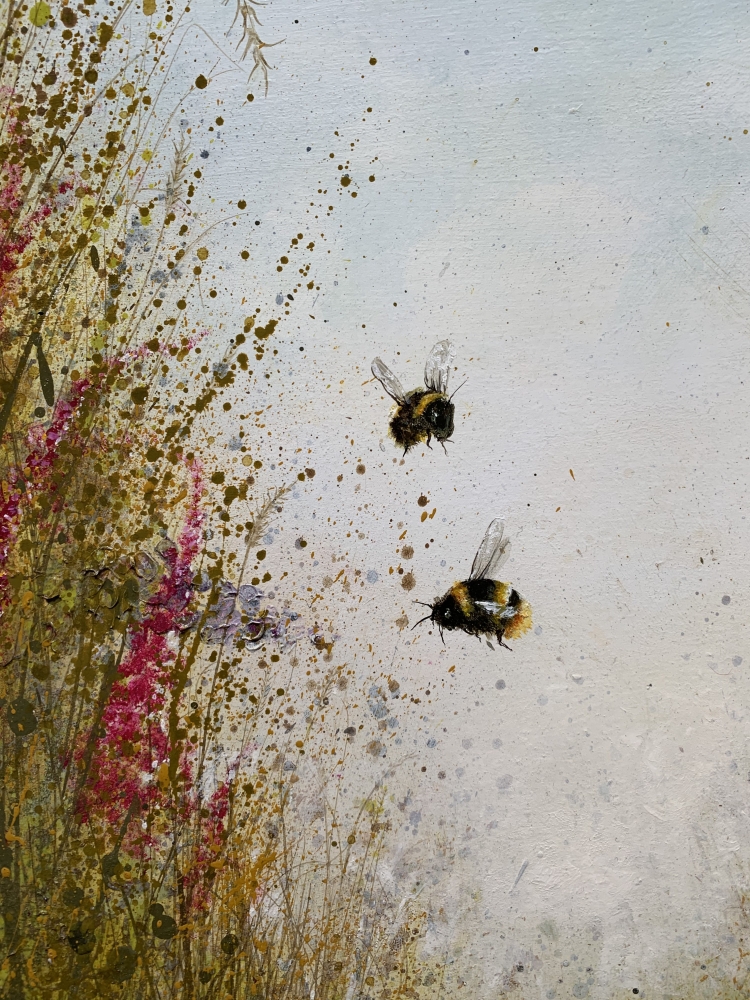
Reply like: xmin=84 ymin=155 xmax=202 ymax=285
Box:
xmin=413 ymin=519 xmax=531 ymax=649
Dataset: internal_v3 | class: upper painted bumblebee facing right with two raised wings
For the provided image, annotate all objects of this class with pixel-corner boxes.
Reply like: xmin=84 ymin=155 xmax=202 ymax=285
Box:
xmin=372 ymin=340 xmax=462 ymax=454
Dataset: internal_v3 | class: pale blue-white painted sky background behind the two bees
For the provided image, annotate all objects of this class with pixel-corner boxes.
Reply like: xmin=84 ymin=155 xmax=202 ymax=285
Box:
xmin=192 ymin=0 xmax=750 ymax=997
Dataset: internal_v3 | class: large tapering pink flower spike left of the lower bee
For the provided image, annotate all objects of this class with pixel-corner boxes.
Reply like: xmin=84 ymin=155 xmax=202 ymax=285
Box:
xmin=75 ymin=462 xmax=203 ymax=828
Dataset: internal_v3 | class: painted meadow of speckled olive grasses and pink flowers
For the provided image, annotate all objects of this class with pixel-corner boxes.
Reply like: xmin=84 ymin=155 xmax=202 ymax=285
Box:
xmin=0 ymin=0 xmax=435 ymax=1000
